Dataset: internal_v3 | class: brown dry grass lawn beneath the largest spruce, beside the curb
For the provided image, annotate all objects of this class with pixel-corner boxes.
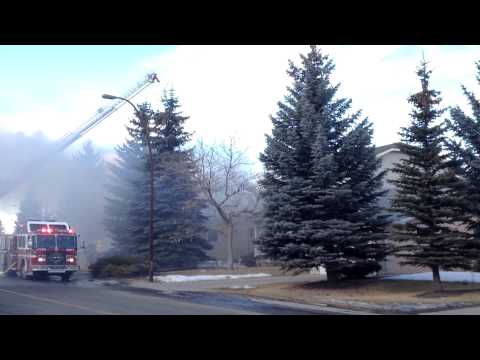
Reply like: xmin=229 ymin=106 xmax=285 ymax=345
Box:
xmin=226 ymin=279 xmax=480 ymax=304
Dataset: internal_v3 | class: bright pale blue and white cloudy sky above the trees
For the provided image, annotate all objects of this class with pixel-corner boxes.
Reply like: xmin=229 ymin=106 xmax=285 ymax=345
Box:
xmin=0 ymin=45 xmax=480 ymax=231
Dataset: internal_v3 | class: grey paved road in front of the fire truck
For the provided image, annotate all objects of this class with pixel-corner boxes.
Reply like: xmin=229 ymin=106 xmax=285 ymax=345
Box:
xmin=0 ymin=274 xmax=350 ymax=315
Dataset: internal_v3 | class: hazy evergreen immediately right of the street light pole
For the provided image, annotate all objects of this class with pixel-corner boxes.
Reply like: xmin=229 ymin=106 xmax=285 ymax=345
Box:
xmin=150 ymin=90 xmax=211 ymax=267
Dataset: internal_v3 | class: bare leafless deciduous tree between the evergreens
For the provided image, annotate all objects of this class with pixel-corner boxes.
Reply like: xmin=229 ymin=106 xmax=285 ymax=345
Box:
xmin=195 ymin=138 xmax=260 ymax=269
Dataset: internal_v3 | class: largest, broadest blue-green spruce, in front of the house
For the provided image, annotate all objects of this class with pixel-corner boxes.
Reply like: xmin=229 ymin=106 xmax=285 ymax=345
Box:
xmin=259 ymin=46 xmax=387 ymax=281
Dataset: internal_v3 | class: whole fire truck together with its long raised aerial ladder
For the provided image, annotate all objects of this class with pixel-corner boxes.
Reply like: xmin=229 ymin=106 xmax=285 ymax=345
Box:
xmin=0 ymin=73 xmax=160 ymax=281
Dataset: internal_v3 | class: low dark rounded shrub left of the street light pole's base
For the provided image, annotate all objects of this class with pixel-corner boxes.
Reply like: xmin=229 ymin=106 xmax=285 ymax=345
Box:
xmin=89 ymin=255 xmax=148 ymax=278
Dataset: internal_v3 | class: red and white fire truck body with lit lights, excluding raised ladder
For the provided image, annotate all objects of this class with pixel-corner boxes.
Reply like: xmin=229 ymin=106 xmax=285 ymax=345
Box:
xmin=0 ymin=220 xmax=80 ymax=281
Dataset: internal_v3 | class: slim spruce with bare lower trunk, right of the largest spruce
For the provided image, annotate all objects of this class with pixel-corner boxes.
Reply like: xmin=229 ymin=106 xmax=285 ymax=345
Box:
xmin=392 ymin=62 xmax=471 ymax=290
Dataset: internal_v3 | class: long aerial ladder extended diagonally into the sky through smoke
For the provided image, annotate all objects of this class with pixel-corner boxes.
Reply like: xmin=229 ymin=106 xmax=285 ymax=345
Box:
xmin=0 ymin=73 xmax=160 ymax=199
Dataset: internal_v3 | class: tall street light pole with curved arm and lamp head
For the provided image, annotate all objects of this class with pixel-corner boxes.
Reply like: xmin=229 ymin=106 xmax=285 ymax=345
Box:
xmin=102 ymin=94 xmax=155 ymax=282
